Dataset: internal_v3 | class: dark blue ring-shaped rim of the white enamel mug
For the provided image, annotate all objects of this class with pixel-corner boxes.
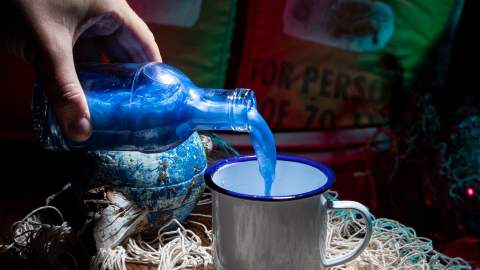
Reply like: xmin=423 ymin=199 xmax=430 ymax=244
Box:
xmin=204 ymin=154 xmax=335 ymax=201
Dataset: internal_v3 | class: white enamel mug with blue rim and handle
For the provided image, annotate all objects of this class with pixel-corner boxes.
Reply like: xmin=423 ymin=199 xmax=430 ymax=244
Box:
xmin=205 ymin=155 xmax=373 ymax=270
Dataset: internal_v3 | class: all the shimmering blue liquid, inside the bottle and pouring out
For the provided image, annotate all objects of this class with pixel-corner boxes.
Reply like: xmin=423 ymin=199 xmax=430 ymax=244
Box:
xmin=87 ymin=89 xmax=276 ymax=197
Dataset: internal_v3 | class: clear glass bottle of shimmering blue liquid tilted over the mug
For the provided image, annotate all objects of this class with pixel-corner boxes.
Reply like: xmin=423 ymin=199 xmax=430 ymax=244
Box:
xmin=33 ymin=63 xmax=255 ymax=152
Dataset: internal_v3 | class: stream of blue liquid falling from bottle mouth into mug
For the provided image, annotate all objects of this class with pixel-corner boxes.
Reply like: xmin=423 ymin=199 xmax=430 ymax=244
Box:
xmin=247 ymin=108 xmax=277 ymax=197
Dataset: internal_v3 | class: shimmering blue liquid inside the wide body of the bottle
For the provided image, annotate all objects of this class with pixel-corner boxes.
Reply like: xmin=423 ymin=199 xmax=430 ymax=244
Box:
xmin=70 ymin=86 xmax=190 ymax=152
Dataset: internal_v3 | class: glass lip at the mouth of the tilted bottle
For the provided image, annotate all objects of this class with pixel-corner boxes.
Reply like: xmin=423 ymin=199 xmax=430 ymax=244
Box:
xmin=230 ymin=88 xmax=257 ymax=132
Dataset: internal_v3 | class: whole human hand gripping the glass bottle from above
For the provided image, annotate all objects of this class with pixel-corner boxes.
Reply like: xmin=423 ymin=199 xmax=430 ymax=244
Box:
xmin=0 ymin=0 xmax=161 ymax=141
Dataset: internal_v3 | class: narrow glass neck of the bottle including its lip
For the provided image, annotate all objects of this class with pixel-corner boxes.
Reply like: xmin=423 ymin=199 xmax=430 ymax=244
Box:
xmin=192 ymin=88 xmax=256 ymax=132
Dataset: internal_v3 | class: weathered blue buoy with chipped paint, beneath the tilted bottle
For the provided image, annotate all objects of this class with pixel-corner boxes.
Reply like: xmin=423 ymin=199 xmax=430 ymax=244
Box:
xmin=90 ymin=133 xmax=207 ymax=228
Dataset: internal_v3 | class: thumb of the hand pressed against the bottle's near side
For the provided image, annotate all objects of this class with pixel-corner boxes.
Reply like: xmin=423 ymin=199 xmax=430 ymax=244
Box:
xmin=41 ymin=35 xmax=92 ymax=142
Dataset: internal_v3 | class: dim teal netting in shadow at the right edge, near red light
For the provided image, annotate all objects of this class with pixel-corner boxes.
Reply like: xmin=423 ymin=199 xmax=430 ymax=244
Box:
xmin=388 ymin=93 xmax=480 ymax=235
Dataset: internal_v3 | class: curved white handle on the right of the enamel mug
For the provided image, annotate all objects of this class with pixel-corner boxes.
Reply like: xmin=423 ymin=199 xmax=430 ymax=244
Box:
xmin=323 ymin=199 xmax=373 ymax=267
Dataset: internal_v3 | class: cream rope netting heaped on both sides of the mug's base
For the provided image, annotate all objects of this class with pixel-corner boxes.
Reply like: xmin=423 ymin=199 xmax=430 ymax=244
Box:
xmin=92 ymin=191 xmax=471 ymax=270
